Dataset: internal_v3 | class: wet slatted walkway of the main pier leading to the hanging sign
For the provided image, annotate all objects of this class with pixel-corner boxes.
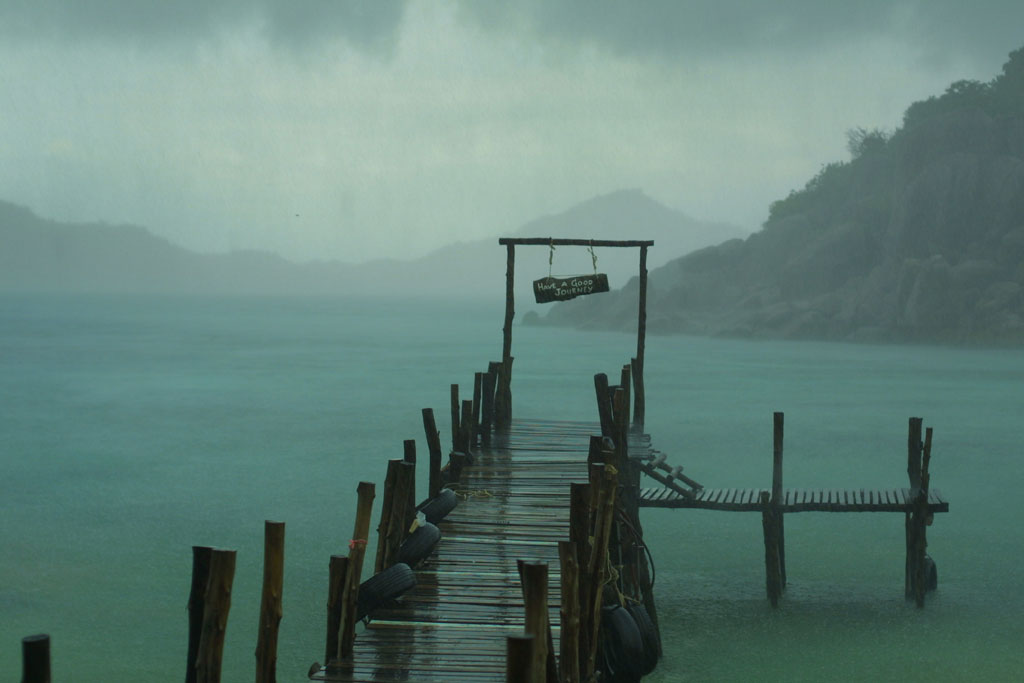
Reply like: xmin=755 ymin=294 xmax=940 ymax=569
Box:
xmin=311 ymin=421 xmax=622 ymax=681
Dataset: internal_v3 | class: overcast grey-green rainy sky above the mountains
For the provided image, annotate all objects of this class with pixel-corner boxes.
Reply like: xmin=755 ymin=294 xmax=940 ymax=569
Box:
xmin=0 ymin=0 xmax=1024 ymax=261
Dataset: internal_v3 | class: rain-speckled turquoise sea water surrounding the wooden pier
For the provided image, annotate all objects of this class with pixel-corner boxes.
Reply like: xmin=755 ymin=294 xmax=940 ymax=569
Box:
xmin=0 ymin=296 xmax=1024 ymax=681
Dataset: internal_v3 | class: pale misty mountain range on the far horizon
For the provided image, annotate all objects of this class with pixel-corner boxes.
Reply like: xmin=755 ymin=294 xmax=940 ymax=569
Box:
xmin=0 ymin=190 xmax=742 ymax=304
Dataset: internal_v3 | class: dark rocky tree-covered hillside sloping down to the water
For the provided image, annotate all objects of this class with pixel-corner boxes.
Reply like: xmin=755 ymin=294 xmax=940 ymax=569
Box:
xmin=544 ymin=48 xmax=1024 ymax=344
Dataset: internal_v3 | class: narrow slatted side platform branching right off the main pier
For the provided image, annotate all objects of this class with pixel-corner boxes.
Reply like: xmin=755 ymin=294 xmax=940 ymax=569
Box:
xmin=640 ymin=487 xmax=949 ymax=513
